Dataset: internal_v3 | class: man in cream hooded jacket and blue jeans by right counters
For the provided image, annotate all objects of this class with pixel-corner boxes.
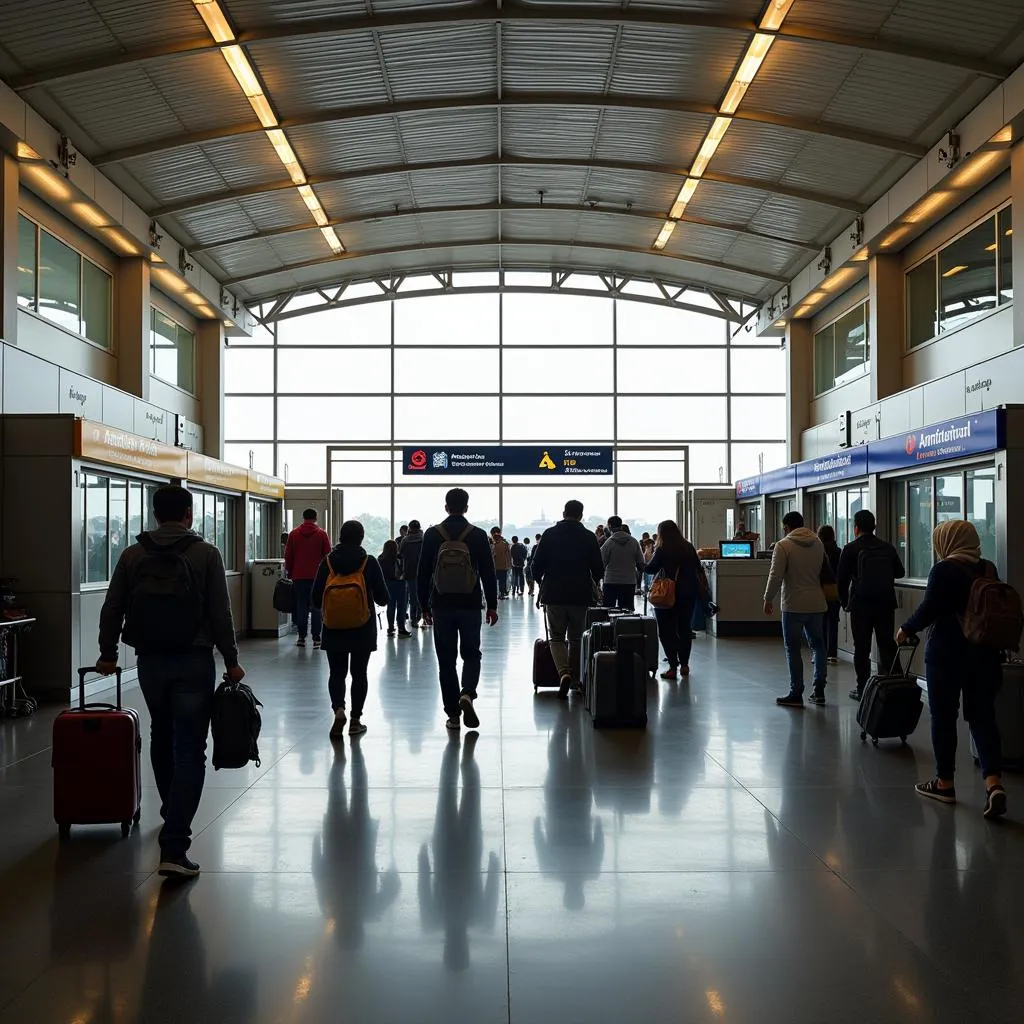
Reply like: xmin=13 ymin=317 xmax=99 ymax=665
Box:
xmin=765 ymin=512 xmax=828 ymax=708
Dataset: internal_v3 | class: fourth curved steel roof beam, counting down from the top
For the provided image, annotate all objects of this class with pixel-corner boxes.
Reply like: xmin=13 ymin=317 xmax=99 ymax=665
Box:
xmin=188 ymin=203 xmax=821 ymax=253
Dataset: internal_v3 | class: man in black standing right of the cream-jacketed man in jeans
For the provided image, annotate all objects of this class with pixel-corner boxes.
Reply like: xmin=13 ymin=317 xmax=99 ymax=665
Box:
xmin=837 ymin=509 xmax=906 ymax=700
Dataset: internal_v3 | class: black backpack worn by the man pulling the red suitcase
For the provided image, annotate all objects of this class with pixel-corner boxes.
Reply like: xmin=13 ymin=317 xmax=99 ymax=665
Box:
xmin=124 ymin=534 xmax=204 ymax=654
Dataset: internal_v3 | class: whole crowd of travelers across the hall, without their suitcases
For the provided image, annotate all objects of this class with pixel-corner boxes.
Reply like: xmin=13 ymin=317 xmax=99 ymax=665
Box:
xmin=90 ymin=485 xmax=1020 ymax=878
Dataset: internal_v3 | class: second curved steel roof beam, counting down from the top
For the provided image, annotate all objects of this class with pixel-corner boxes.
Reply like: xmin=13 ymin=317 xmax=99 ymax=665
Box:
xmin=91 ymin=92 xmax=928 ymax=167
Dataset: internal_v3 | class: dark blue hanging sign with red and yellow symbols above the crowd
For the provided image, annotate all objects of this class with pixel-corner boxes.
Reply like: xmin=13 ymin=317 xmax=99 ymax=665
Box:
xmin=401 ymin=444 xmax=613 ymax=476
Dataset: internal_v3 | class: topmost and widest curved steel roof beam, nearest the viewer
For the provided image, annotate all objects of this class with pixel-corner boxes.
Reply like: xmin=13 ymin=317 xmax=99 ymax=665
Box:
xmin=9 ymin=0 xmax=1014 ymax=90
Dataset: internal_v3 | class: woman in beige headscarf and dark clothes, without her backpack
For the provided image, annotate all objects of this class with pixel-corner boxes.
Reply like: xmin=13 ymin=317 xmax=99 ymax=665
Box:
xmin=896 ymin=519 xmax=1007 ymax=818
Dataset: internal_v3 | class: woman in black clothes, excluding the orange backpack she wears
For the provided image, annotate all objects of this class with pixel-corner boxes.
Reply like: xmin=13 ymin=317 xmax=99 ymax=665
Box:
xmin=311 ymin=519 xmax=388 ymax=739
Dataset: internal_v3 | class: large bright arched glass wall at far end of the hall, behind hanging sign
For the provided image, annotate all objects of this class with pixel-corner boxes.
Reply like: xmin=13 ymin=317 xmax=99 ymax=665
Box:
xmin=224 ymin=293 xmax=785 ymax=546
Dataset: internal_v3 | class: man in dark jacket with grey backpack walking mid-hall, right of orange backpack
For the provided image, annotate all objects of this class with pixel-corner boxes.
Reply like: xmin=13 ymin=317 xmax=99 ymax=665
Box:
xmin=419 ymin=487 xmax=498 ymax=731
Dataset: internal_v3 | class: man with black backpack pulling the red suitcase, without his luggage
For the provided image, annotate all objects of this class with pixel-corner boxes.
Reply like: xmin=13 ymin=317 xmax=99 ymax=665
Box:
xmin=96 ymin=486 xmax=245 ymax=878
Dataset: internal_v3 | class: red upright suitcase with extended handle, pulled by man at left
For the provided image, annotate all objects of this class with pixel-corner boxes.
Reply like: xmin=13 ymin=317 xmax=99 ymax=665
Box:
xmin=51 ymin=669 xmax=142 ymax=838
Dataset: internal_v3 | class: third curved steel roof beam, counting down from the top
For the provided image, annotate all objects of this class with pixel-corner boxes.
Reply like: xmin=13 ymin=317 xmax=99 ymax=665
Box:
xmin=150 ymin=157 xmax=867 ymax=220
